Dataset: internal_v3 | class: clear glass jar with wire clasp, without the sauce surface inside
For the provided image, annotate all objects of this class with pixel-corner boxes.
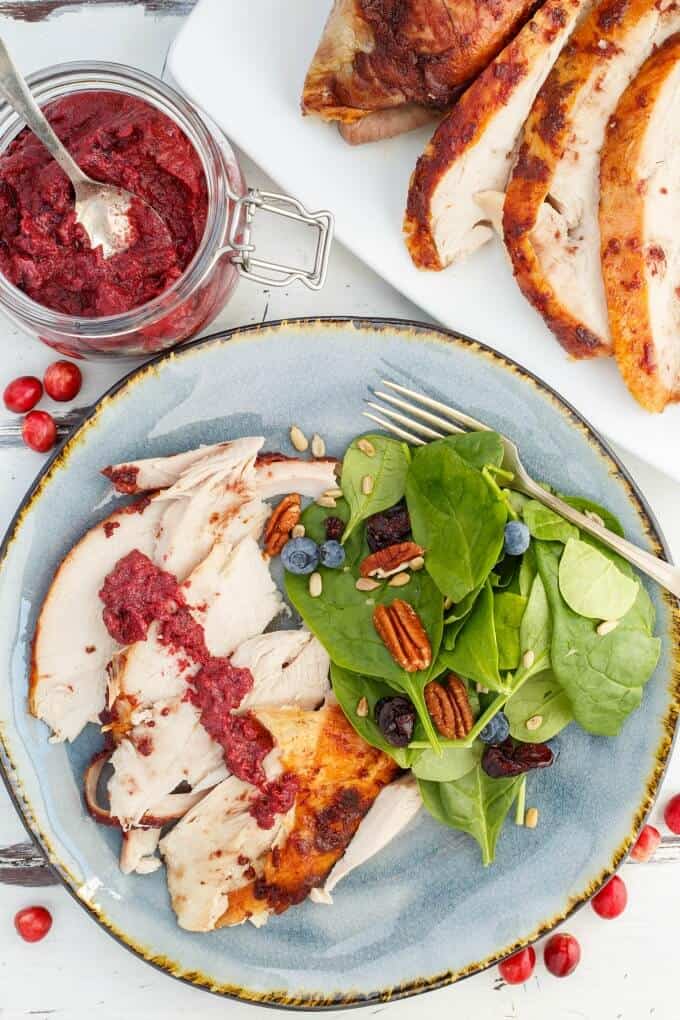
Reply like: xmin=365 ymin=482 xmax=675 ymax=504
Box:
xmin=0 ymin=62 xmax=332 ymax=358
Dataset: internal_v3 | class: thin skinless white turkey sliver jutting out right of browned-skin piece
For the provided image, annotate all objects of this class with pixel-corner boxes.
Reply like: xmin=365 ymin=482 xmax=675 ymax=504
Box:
xmin=309 ymin=772 xmax=423 ymax=904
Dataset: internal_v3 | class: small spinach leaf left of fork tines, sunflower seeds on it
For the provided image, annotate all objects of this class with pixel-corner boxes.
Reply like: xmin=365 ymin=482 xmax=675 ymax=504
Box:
xmin=341 ymin=435 xmax=411 ymax=542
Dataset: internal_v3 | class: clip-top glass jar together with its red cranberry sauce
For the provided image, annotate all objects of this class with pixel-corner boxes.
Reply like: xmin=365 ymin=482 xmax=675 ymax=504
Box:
xmin=0 ymin=62 xmax=332 ymax=358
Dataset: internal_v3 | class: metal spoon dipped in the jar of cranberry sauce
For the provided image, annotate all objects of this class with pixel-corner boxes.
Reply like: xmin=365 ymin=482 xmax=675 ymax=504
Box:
xmin=0 ymin=39 xmax=168 ymax=258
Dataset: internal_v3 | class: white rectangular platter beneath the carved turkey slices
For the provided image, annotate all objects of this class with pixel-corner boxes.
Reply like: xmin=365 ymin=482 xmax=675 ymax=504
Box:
xmin=168 ymin=0 xmax=680 ymax=479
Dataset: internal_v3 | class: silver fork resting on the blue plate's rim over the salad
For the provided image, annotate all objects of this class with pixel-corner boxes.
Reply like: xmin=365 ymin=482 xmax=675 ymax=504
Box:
xmin=363 ymin=379 xmax=680 ymax=597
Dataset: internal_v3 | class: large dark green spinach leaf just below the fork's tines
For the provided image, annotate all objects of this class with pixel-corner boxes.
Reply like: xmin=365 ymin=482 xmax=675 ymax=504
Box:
xmin=406 ymin=443 xmax=507 ymax=603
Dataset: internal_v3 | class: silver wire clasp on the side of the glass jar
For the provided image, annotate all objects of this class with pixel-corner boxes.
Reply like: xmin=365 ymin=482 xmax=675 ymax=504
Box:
xmin=227 ymin=188 xmax=334 ymax=291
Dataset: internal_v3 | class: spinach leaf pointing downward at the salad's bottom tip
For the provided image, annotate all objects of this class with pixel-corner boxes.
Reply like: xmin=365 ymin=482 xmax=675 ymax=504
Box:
xmin=418 ymin=765 xmax=522 ymax=866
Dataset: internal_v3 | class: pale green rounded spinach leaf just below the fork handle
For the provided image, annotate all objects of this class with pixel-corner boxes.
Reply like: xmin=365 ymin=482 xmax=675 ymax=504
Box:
xmin=559 ymin=539 xmax=639 ymax=620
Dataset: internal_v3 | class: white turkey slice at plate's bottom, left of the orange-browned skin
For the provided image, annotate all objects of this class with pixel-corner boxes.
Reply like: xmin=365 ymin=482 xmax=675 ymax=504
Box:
xmin=160 ymin=776 xmax=295 ymax=931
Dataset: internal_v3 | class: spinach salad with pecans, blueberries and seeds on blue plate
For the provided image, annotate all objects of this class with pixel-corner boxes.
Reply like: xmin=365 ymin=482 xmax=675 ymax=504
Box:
xmin=282 ymin=432 xmax=660 ymax=865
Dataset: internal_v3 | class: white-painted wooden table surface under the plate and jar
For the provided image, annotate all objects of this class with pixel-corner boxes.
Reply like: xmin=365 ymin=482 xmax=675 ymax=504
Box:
xmin=0 ymin=0 xmax=680 ymax=1020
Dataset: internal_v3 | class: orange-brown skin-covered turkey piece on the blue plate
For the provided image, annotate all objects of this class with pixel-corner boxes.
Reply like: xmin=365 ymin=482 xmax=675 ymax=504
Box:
xmin=217 ymin=706 xmax=399 ymax=927
